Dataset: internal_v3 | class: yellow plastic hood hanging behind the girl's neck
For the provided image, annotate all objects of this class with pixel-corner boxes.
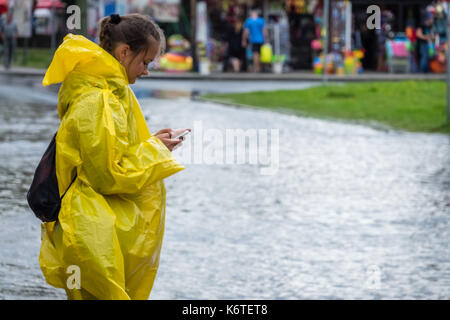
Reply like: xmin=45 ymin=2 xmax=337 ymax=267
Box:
xmin=42 ymin=33 xmax=129 ymax=86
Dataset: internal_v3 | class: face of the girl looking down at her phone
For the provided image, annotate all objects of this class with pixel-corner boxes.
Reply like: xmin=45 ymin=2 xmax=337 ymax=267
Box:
xmin=115 ymin=40 xmax=159 ymax=84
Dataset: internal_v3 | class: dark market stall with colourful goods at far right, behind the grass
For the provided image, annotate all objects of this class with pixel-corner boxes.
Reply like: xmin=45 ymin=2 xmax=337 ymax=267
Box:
xmin=351 ymin=0 xmax=447 ymax=72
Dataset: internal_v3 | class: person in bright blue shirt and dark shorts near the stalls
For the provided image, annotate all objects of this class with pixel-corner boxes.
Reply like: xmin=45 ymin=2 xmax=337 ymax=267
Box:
xmin=242 ymin=10 xmax=268 ymax=72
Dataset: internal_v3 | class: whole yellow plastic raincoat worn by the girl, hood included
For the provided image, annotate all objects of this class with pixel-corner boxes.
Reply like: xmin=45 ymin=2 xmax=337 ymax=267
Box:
xmin=39 ymin=34 xmax=184 ymax=299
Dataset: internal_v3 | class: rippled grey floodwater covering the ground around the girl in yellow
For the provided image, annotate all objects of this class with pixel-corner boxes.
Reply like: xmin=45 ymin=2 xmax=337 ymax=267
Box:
xmin=0 ymin=76 xmax=450 ymax=299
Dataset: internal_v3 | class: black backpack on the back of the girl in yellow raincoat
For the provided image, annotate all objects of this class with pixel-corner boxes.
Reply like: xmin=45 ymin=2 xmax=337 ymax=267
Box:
xmin=27 ymin=132 xmax=77 ymax=222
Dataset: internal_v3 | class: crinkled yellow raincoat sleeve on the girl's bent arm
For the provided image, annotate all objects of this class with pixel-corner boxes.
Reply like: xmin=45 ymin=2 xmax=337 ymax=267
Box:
xmin=69 ymin=88 xmax=184 ymax=194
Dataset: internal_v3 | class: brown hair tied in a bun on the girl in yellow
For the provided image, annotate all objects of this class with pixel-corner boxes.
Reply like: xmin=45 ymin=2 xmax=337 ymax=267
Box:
xmin=98 ymin=13 xmax=166 ymax=56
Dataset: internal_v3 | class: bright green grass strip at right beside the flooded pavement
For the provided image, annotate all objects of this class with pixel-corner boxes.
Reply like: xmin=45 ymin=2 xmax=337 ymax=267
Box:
xmin=202 ymin=81 xmax=450 ymax=133
